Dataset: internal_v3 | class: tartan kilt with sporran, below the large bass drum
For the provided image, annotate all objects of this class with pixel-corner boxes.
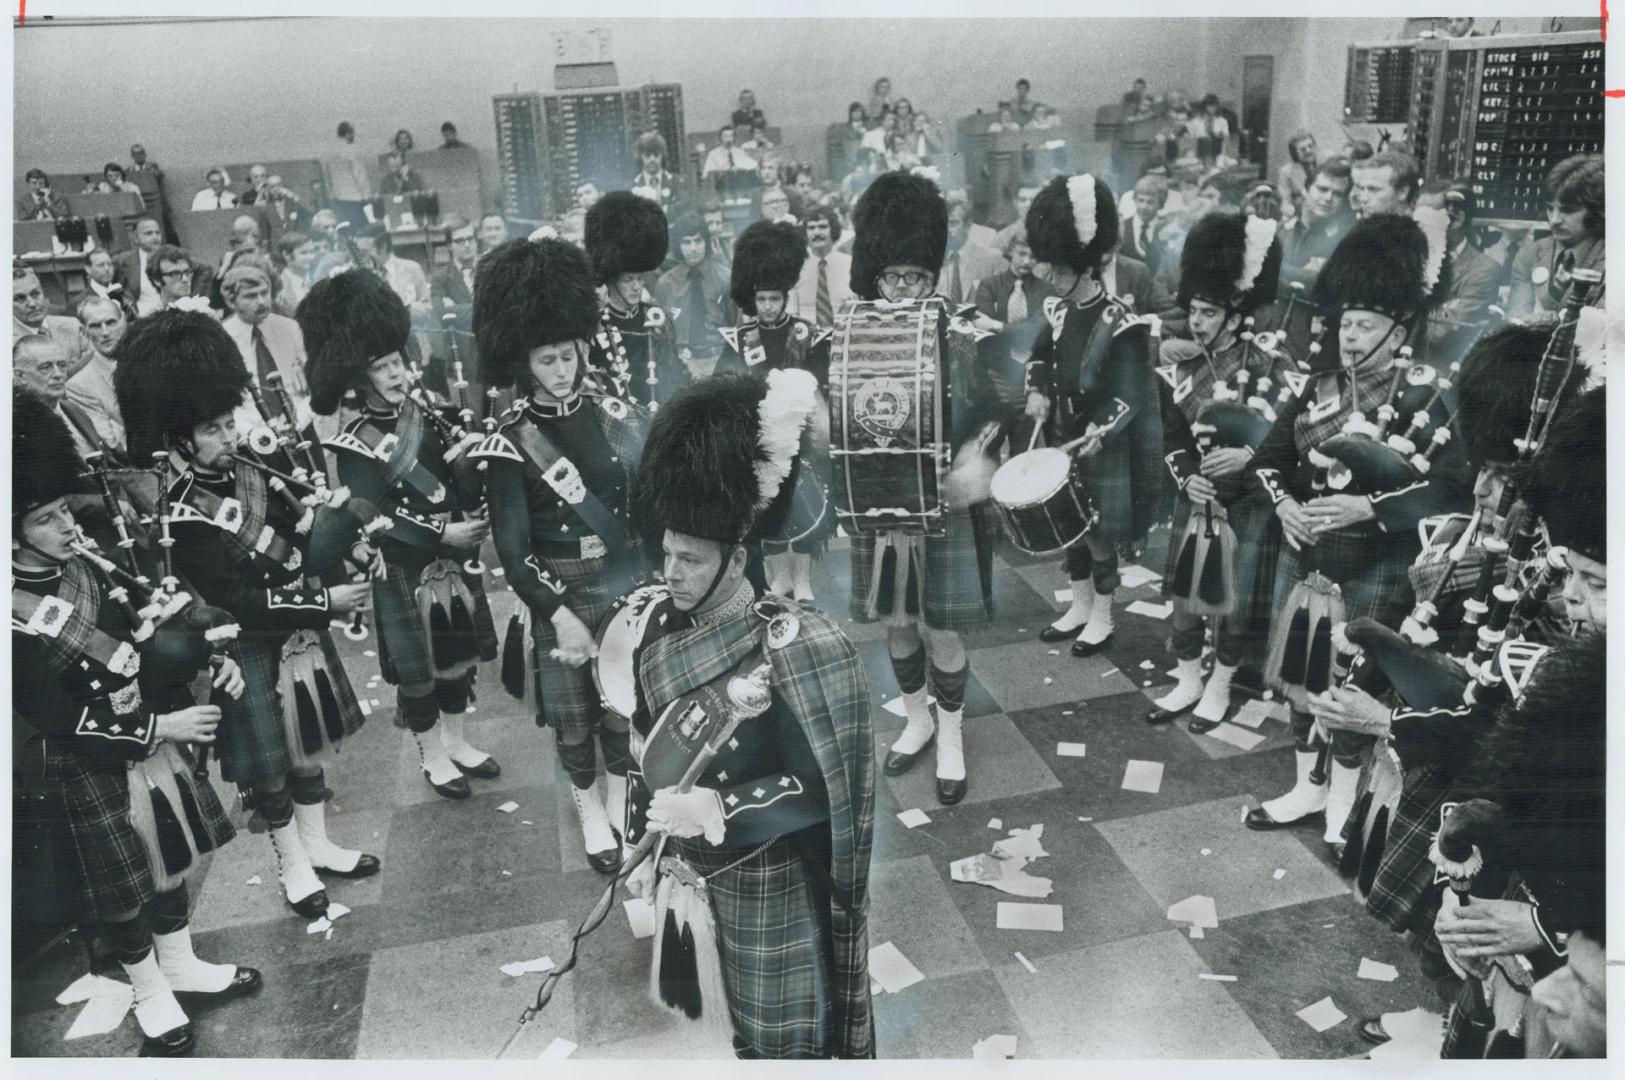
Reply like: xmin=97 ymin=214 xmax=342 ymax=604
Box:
xmin=850 ymin=508 xmax=986 ymax=630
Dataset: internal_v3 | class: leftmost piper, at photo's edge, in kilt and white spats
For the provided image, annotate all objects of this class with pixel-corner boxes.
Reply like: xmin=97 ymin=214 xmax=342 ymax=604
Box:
xmin=11 ymin=393 xmax=262 ymax=1057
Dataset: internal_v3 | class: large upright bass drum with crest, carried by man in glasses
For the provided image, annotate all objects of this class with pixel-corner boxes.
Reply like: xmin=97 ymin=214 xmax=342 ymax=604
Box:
xmin=829 ymin=297 xmax=949 ymax=534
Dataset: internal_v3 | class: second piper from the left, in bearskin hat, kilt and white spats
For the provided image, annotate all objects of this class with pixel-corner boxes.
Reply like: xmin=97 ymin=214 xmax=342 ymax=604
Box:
xmin=114 ymin=310 xmax=379 ymax=919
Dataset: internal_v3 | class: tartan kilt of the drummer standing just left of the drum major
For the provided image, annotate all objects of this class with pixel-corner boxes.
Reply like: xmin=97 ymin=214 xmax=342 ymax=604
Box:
xmin=530 ymin=554 xmax=637 ymax=744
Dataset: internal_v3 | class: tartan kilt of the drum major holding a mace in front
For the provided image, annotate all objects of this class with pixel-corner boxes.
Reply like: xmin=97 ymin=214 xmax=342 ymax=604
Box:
xmin=671 ymin=838 xmax=835 ymax=1059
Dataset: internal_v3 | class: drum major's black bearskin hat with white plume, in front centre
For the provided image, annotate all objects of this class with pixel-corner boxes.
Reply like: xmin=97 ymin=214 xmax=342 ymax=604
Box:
xmin=631 ymin=370 xmax=817 ymax=546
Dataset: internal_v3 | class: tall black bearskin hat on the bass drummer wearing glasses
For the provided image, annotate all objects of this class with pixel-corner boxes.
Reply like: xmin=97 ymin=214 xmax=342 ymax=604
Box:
xmin=850 ymin=172 xmax=947 ymax=300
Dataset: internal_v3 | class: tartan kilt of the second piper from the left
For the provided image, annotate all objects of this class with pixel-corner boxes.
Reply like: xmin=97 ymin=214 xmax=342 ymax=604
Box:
xmin=215 ymin=630 xmax=367 ymax=788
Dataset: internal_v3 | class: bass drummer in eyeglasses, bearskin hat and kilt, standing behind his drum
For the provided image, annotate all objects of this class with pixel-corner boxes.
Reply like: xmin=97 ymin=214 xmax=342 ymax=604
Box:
xmin=837 ymin=172 xmax=985 ymax=806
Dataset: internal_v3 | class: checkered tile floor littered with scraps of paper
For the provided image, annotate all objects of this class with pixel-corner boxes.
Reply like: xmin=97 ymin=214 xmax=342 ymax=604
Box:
xmin=11 ymin=534 xmax=1438 ymax=1059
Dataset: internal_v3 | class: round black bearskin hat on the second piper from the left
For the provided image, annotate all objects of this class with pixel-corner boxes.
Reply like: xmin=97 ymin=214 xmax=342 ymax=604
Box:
xmin=112 ymin=309 xmax=250 ymax=463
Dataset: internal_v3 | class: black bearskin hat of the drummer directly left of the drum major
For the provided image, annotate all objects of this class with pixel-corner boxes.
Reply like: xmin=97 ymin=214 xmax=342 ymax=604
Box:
xmin=475 ymin=240 xmax=598 ymax=387
